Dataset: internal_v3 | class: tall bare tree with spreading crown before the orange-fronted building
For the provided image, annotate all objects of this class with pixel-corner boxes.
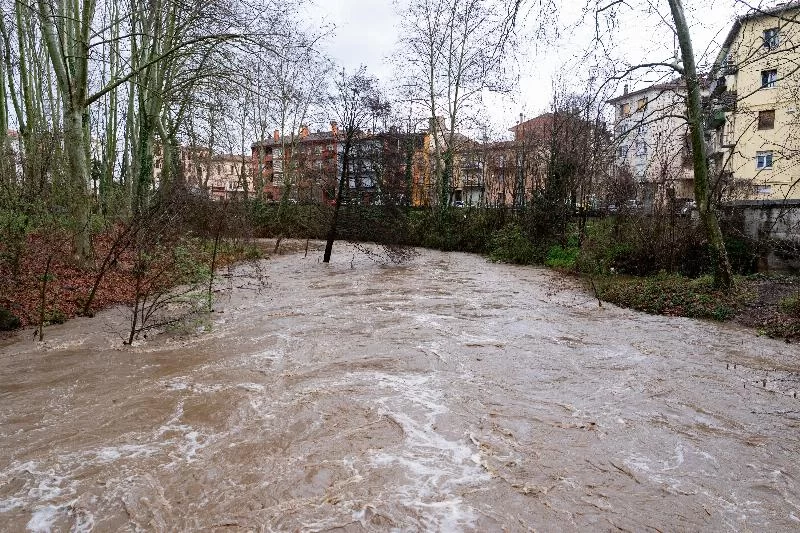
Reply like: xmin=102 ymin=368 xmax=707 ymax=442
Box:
xmin=400 ymin=0 xmax=522 ymax=212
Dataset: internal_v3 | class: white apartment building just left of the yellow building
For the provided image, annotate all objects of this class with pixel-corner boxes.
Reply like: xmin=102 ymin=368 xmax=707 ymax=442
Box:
xmin=608 ymin=79 xmax=694 ymax=209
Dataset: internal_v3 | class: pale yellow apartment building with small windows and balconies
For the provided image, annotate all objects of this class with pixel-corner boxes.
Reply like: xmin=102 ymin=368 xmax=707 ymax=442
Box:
xmin=712 ymin=1 xmax=800 ymax=200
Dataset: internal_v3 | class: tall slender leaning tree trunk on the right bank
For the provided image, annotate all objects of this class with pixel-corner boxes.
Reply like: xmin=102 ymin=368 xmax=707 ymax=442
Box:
xmin=669 ymin=0 xmax=733 ymax=291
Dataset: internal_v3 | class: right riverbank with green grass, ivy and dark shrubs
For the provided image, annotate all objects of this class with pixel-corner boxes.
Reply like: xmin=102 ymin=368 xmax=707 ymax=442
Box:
xmin=488 ymin=214 xmax=800 ymax=340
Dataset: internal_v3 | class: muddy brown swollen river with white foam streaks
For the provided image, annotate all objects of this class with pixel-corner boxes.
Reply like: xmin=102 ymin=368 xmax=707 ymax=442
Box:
xmin=0 ymin=244 xmax=800 ymax=532
